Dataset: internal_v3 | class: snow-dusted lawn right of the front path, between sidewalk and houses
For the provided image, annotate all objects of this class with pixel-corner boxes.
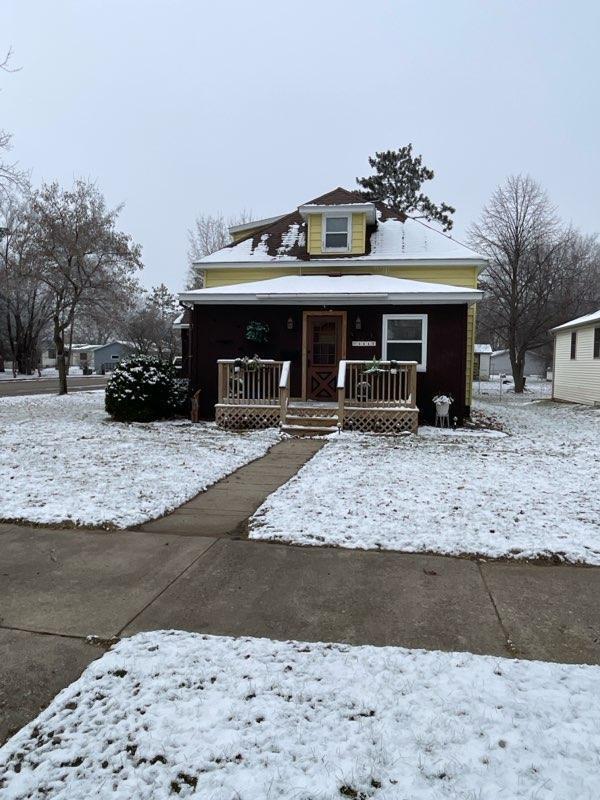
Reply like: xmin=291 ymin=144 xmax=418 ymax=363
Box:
xmin=250 ymin=386 xmax=600 ymax=564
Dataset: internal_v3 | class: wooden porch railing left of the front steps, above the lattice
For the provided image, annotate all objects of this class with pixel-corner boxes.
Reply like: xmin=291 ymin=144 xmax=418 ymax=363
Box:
xmin=217 ymin=358 xmax=290 ymax=406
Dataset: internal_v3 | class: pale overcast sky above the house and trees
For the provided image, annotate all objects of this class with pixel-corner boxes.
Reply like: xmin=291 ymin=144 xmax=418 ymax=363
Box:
xmin=0 ymin=0 xmax=600 ymax=290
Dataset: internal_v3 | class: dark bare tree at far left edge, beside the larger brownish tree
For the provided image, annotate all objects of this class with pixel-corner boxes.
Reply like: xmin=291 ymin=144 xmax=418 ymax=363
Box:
xmin=0 ymin=193 xmax=50 ymax=375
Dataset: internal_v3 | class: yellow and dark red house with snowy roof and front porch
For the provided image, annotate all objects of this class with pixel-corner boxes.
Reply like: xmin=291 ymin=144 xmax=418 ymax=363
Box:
xmin=180 ymin=188 xmax=486 ymax=433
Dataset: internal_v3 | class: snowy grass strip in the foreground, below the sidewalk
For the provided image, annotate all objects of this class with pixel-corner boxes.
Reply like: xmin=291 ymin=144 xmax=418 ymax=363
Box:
xmin=0 ymin=631 xmax=600 ymax=800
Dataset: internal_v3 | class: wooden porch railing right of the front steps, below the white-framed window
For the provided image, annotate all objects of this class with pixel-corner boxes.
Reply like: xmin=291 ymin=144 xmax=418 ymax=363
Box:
xmin=337 ymin=361 xmax=417 ymax=421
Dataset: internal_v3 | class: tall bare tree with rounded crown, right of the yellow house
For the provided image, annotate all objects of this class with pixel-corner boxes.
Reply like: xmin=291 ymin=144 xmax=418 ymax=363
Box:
xmin=469 ymin=175 xmax=597 ymax=392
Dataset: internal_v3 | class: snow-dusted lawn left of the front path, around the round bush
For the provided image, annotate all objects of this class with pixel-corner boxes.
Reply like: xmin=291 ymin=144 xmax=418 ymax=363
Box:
xmin=0 ymin=392 xmax=277 ymax=528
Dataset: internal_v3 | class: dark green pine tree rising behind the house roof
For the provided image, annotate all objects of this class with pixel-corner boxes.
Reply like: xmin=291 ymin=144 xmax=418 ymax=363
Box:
xmin=356 ymin=144 xmax=456 ymax=231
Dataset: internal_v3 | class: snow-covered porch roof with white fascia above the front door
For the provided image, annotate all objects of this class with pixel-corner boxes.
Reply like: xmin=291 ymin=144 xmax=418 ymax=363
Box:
xmin=179 ymin=275 xmax=483 ymax=306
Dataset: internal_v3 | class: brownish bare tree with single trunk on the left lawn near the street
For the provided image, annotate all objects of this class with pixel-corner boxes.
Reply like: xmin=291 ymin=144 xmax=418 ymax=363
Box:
xmin=32 ymin=180 xmax=141 ymax=394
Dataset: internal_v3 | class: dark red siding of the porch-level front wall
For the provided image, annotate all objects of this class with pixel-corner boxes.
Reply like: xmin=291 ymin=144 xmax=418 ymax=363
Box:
xmin=190 ymin=305 xmax=469 ymax=420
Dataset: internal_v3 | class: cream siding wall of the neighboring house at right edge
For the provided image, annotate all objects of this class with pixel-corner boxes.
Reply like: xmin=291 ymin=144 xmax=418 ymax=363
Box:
xmin=553 ymin=325 xmax=600 ymax=405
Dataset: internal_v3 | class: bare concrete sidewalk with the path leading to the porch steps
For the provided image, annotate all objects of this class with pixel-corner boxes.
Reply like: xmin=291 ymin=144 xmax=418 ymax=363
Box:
xmin=0 ymin=441 xmax=600 ymax=742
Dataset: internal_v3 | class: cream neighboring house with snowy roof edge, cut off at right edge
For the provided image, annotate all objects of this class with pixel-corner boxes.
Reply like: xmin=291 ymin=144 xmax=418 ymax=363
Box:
xmin=552 ymin=310 xmax=600 ymax=406
